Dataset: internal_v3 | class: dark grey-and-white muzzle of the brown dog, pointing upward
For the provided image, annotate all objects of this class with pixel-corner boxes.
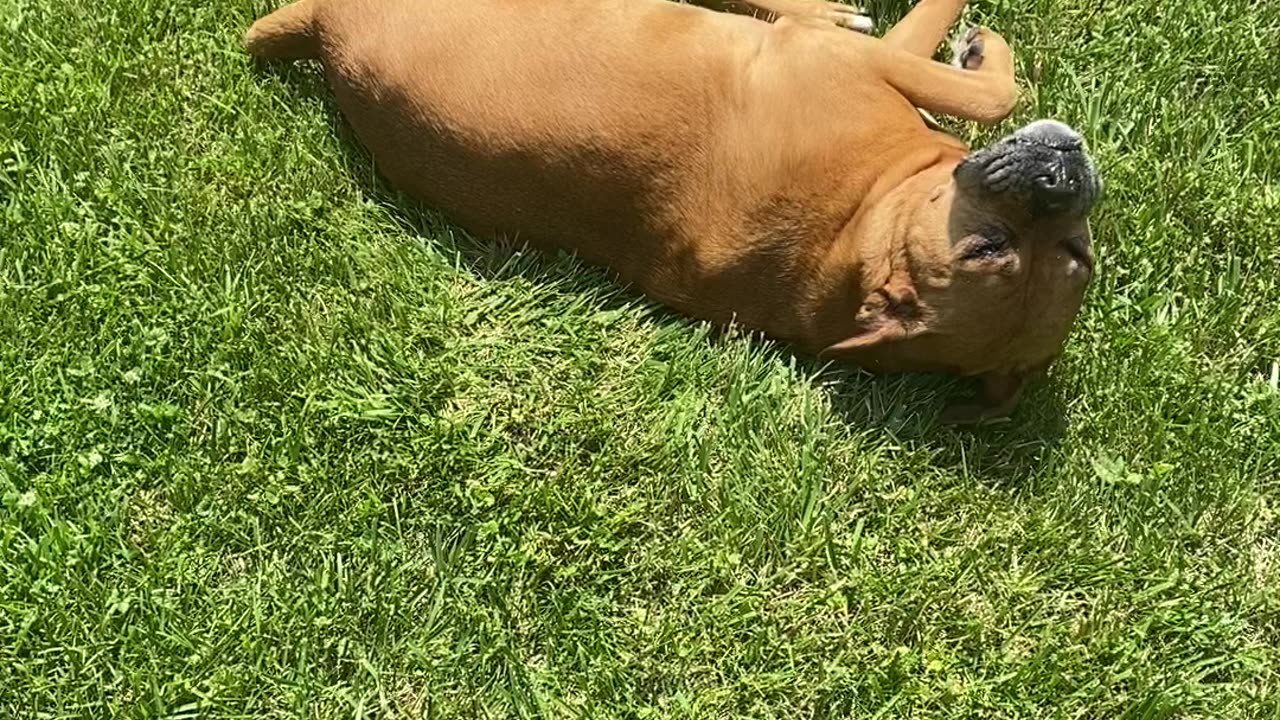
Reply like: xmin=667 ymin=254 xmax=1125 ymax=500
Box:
xmin=955 ymin=120 xmax=1102 ymax=215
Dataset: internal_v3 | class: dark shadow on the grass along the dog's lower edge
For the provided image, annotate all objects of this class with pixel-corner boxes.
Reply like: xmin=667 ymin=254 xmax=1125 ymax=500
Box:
xmin=261 ymin=63 xmax=1066 ymax=486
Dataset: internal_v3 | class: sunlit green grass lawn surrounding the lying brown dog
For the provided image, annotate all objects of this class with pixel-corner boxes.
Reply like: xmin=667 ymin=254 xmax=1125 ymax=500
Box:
xmin=0 ymin=0 xmax=1280 ymax=719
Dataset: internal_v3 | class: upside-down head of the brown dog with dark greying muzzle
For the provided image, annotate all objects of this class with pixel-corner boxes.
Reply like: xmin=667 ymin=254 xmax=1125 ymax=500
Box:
xmin=824 ymin=120 xmax=1102 ymax=375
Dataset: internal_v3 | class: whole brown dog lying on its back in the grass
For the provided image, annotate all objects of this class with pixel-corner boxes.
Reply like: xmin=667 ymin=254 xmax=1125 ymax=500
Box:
xmin=246 ymin=0 xmax=1101 ymax=421
